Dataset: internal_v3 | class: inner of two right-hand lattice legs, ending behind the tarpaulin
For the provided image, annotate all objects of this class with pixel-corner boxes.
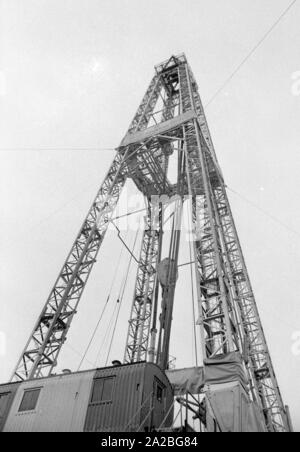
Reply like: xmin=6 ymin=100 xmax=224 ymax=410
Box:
xmin=185 ymin=121 xmax=239 ymax=358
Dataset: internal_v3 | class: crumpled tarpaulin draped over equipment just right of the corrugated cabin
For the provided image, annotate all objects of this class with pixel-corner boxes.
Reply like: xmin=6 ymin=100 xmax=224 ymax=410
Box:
xmin=166 ymin=353 xmax=247 ymax=394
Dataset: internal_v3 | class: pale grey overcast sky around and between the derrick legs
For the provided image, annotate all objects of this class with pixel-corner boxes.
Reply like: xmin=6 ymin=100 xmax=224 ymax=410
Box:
xmin=0 ymin=0 xmax=300 ymax=431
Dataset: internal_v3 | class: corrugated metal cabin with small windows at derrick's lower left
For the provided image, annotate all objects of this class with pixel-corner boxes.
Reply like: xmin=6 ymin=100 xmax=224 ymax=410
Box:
xmin=0 ymin=363 xmax=174 ymax=432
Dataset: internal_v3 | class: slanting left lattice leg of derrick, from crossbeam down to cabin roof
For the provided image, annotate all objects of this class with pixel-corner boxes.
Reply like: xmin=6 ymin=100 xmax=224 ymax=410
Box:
xmin=12 ymin=152 xmax=128 ymax=381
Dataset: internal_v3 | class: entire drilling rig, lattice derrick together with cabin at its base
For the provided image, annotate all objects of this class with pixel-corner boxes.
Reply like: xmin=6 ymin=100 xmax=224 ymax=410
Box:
xmin=0 ymin=54 xmax=292 ymax=432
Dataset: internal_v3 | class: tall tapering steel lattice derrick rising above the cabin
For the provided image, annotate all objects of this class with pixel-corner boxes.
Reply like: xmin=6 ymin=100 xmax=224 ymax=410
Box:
xmin=13 ymin=55 xmax=289 ymax=432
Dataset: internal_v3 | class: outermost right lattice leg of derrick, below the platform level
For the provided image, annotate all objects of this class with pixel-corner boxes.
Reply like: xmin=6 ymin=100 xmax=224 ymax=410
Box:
xmin=214 ymin=183 xmax=288 ymax=432
